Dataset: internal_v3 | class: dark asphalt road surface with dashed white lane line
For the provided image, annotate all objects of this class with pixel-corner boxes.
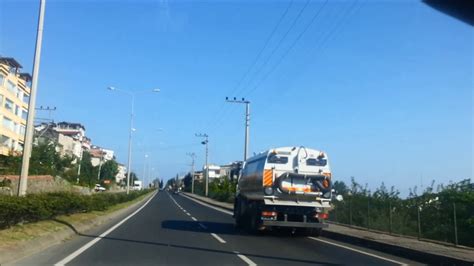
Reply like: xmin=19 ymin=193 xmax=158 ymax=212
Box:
xmin=12 ymin=192 xmax=417 ymax=265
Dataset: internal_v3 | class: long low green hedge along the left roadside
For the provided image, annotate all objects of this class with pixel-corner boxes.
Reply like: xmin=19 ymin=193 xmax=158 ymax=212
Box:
xmin=0 ymin=189 xmax=150 ymax=229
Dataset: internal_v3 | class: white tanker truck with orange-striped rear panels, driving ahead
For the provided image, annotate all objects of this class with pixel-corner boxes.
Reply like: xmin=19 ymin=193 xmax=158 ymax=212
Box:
xmin=233 ymin=147 xmax=332 ymax=236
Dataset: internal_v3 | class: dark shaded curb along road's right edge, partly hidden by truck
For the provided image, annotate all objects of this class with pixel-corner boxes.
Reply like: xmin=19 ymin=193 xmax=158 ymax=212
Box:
xmin=183 ymin=193 xmax=474 ymax=265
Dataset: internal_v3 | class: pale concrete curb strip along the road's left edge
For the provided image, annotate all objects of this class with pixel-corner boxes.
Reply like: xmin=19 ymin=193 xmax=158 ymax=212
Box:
xmin=0 ymin=192 xmax=156 ymax=265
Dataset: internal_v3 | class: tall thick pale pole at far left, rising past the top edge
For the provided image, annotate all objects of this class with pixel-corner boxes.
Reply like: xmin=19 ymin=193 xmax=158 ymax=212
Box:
xmin=18 ymin=0 xmax=46 ymax=196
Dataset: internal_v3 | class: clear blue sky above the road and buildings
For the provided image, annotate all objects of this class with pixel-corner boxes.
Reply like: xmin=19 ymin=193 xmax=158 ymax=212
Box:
xmin=0 ymin=0 xmax=474 ymax=194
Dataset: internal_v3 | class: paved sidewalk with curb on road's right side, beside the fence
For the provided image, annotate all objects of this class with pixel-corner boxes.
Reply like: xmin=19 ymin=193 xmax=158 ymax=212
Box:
xmin=184 ymin=193 xmax=474 ymax=265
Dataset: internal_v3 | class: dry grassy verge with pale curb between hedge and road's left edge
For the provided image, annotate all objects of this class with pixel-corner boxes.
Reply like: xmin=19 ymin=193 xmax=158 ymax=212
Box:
xmin=0 ymin=192 xmax=156 ymax=265
